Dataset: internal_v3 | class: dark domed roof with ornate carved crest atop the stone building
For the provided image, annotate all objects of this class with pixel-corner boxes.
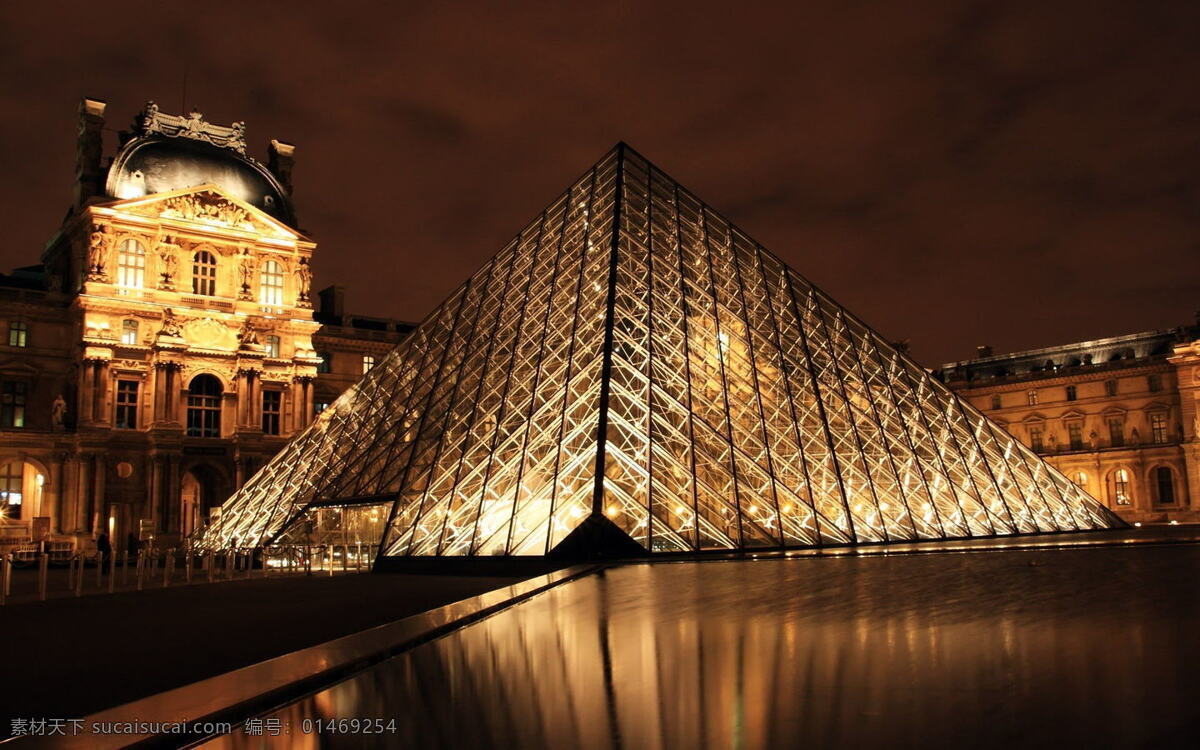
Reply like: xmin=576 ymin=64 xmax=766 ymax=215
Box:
xmin=104 ymin=104 xmax=295 ymax=228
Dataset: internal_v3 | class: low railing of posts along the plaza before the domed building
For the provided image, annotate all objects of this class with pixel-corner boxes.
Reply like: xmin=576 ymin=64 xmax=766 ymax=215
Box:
xmin=0 ymin=544 xmax=378 ymax=605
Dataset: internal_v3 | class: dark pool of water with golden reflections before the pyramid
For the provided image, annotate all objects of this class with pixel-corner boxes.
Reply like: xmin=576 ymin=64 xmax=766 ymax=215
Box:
xmin=209 ymin=546 xmax=1200 ymax=749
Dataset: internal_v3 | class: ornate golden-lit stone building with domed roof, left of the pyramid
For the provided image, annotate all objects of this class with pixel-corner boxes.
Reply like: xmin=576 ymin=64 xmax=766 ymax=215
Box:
xmin=0 ymin=100 xmax=410 ymax=546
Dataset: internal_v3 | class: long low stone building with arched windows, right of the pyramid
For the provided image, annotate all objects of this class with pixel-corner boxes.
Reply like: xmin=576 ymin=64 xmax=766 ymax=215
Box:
xmin=938 ymin=325 xmax=1200 ymax=523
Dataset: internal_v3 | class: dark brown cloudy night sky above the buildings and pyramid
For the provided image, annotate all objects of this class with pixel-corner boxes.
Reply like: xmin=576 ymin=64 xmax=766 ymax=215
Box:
xmin=0 ymin=0 xmax=1200 ymax=365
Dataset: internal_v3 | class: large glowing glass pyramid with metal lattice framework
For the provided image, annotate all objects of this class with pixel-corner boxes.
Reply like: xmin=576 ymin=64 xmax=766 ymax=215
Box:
xmin=200 ymin=144 xmax=1123 ymax=556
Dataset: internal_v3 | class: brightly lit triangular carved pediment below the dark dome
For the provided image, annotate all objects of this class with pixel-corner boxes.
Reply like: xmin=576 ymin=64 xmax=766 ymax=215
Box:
xmin=112 ymin=185 xmax=299 ymax=239
